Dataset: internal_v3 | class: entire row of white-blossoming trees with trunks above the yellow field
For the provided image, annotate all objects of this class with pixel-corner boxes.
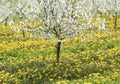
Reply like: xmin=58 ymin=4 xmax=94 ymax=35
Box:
xmin=0 ymin=0 xmax=120 ymax=62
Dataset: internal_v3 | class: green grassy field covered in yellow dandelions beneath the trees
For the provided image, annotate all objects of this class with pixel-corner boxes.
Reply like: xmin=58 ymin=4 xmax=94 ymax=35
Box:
xmin=0 ymin=19 xmax=120 ymax=84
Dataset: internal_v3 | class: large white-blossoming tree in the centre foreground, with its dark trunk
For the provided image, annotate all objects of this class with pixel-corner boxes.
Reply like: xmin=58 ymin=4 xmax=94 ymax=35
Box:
xmin=40 ymin=0 xmax=78 ymax=63
